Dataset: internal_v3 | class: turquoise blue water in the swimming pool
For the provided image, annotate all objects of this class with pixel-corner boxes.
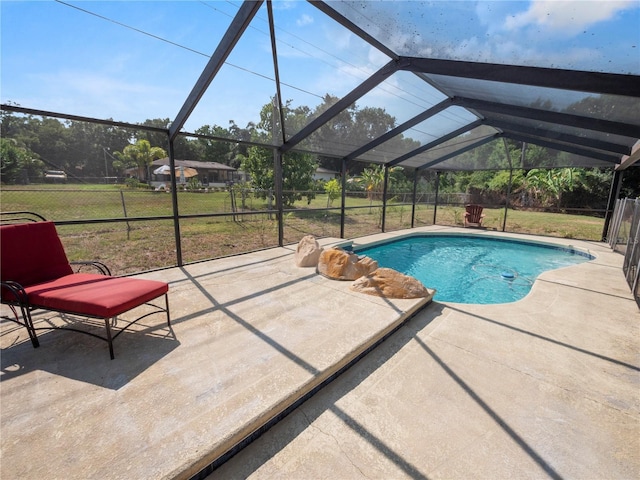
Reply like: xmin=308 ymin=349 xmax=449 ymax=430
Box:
xmin=355 ymin=235 xmax=594 ymax=304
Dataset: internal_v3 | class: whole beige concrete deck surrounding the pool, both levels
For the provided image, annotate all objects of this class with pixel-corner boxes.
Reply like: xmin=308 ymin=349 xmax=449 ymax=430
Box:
xmin=0 ymin=227 xmax=640 ymax=479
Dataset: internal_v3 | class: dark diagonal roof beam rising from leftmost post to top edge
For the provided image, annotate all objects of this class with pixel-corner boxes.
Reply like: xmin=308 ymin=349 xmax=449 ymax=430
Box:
xmin=169 ymin=0 xmax=264 ymax=140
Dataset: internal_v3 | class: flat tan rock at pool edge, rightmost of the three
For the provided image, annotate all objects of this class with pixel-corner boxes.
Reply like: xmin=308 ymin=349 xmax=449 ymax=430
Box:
xmin=351 ymin=268 xmax=436 ymax=298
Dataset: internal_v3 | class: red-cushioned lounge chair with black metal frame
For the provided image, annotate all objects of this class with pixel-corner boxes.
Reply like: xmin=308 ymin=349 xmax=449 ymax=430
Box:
xmin=0 ymin=221 xmax=171 ymax=360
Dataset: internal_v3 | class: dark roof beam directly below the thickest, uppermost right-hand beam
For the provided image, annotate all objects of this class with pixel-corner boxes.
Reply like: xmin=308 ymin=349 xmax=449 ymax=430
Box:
xmin=453 ymin=97 xmax=640 ymax=138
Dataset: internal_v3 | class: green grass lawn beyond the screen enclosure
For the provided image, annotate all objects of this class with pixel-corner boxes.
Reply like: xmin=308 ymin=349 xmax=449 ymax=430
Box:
xmin=0 ymin=185 xmax=604 ymax=274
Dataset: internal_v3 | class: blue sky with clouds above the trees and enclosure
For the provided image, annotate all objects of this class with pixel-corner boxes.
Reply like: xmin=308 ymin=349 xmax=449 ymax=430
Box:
xmin=0 ymin=0 xmax=640 ymax=137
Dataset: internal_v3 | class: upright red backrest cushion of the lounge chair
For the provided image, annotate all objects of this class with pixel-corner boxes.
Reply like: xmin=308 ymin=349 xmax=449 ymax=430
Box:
xmin=0 ymin=222 xmax=73 ymax=288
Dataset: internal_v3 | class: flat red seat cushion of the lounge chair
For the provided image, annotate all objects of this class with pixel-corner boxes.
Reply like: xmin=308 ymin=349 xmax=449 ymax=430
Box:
xmin=25 ymin=273 xmax=169 ymax=318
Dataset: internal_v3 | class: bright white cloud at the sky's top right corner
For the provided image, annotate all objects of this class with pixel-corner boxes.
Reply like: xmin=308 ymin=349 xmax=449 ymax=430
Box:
xmin=504 ymin=0 xmax=638 ymax=34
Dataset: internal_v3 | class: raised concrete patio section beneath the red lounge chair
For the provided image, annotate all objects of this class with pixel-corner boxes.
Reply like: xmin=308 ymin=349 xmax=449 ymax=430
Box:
xmin=0 ymin=240 xmax=425 ymax=478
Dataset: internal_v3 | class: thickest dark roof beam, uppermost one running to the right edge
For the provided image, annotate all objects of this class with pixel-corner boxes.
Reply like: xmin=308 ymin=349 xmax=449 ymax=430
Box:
xmin=400 ymin=57 xmax=640 ymax=97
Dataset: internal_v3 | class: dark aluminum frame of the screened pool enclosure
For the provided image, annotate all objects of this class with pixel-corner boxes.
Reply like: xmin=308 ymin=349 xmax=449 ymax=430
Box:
xmin=1 ymin=0 xmax=640 ymax=265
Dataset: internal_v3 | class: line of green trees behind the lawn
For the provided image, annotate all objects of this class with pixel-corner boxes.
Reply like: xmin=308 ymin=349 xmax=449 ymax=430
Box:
xmin=0 ymin=95 xmax=640 ymax=208
